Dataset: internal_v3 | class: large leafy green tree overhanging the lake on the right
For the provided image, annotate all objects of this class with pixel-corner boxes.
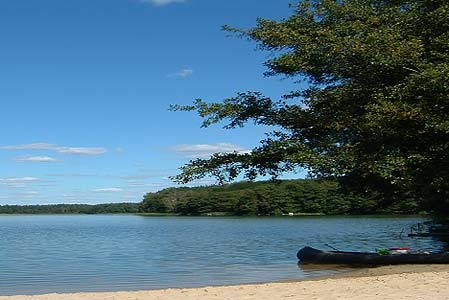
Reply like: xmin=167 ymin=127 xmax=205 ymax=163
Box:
xmin=172 ymin=0 xmax=449 ymax=213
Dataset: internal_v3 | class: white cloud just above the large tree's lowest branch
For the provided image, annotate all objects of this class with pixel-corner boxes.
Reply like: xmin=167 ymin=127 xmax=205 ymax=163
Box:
xmin=168 ymin=143 xmax=249 ymax=158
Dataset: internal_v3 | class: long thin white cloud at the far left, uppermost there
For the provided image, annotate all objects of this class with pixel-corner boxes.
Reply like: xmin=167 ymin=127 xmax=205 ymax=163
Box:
xmin=0 ymin=143 xmax=106 ymax=155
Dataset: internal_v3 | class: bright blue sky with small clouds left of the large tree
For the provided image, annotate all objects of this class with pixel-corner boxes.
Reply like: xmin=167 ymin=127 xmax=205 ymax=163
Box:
xmin=0 ymin=0 xmax=299 ymax=204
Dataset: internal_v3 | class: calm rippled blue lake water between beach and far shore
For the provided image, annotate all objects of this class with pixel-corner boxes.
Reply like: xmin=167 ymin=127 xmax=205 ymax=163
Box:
xmin=0 ymin=215 xmax=443 ymax=295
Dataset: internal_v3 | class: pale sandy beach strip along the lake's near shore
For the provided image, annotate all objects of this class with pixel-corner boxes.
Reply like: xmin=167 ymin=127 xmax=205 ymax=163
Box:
xmin=0 ymin=265 xmax=449 ymax=300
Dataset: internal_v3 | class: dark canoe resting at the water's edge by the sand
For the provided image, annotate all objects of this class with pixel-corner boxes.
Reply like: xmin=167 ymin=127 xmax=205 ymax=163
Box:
xmin=296 ymin=247 xmax=449 ymax=266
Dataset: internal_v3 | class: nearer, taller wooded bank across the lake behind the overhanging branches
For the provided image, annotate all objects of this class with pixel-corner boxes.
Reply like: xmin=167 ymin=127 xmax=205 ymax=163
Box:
xmin=139 ymin=179 xmax=420 ymax=216
